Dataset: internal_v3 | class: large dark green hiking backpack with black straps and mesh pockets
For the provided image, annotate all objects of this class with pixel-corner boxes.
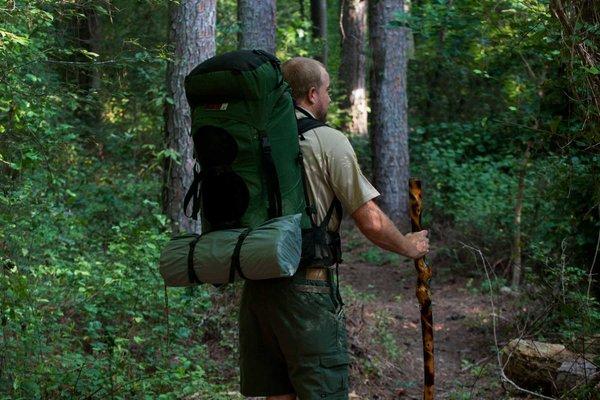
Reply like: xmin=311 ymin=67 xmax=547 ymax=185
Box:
xmin=184 ymin=50 xmax=341 ymax=282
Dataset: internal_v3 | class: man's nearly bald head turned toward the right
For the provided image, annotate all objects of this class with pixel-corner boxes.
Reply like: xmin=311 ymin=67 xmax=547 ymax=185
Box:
xmin=281 ymin=57 xmax=331 ymax=121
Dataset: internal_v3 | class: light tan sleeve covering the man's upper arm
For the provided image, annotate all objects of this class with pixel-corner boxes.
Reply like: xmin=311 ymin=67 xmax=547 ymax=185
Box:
xmin=323 ymin=129 xmax=379 ymax=214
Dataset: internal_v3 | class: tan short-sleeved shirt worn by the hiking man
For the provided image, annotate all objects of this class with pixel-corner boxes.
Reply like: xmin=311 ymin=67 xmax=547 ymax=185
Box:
xmin=296 ymin=110 xmax=379 ymax=231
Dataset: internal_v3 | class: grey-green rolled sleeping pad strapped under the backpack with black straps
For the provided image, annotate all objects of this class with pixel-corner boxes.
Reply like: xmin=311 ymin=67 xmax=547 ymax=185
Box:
xmin=159 ymin=214 xmax=302 ymax=287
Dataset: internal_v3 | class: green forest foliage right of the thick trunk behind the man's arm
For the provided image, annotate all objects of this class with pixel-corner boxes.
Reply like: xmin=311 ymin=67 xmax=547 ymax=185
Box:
xmin=400 ymin=0 xmax=600 ymax=368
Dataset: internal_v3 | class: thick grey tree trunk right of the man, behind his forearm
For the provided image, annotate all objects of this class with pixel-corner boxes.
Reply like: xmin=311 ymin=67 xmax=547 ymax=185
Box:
xmin=369 ymin=0 xmax=410 ymax=232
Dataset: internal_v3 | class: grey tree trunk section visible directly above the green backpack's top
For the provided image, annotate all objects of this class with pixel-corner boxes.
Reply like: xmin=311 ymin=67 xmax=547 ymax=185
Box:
xmin=238 ymin=0 xmax=276 ymax=54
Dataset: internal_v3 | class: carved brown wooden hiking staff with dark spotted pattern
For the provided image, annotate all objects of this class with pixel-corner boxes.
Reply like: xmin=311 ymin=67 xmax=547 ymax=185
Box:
xmin=408 ymin=178 xmax=435 ymax=400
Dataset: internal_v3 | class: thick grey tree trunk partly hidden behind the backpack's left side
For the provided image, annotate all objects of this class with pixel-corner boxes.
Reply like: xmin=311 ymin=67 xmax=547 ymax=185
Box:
xmin=163 ymin=0 xmax=217 ymax=232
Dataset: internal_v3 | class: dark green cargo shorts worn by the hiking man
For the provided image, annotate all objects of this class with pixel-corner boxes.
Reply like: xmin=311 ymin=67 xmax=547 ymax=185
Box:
xmin=239 ymin=271 xmax=348 ymax=400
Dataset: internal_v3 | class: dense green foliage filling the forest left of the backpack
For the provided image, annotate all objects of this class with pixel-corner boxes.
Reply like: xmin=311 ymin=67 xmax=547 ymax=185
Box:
xmin=0 ymin=1 xmax=241 ymax=399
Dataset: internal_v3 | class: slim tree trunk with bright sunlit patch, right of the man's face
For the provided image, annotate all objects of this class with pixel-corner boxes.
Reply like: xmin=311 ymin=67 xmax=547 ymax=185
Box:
xmin=340 ymin=0 xmax=367 ymax=135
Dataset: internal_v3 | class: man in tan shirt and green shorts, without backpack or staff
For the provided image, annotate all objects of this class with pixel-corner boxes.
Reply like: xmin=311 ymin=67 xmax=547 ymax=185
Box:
xmin=240 ymin=57 xmax=429 ymax=400
